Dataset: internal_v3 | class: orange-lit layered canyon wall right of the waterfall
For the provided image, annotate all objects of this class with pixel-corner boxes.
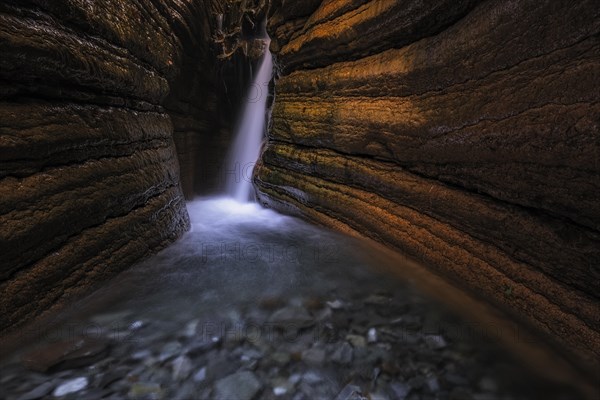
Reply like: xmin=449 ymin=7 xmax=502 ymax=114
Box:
xmin=254 ymin=0 xmax=600 ymax=375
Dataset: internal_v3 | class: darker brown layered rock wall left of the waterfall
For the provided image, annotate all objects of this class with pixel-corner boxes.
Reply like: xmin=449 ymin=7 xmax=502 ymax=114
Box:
xmin=0 ymin=0 xmax=195 ymax=330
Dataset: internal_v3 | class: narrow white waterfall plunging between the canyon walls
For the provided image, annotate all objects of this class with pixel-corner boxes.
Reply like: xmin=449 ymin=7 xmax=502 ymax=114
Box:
xmin=226 ymin=48 xmax=273 ymax=203
